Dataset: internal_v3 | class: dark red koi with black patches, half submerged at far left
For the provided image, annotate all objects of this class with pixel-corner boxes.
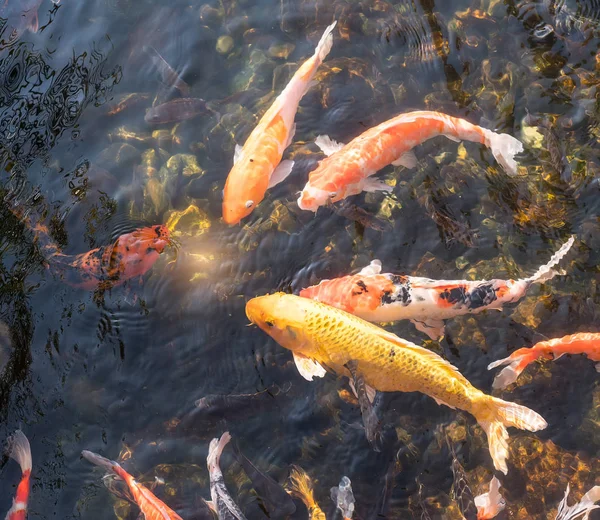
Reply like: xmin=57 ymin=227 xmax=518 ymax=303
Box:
xmin=34 ymin=224 xmax=171 ymax=290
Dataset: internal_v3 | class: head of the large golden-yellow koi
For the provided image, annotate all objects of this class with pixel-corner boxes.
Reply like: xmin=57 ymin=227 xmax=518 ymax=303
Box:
xmin=246 ymin=293 xmax=311 ymax=353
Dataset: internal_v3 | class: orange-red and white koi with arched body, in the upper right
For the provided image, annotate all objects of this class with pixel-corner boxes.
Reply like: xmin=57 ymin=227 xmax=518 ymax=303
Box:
xmin=298 ymin=111 xmax=523 ymax=212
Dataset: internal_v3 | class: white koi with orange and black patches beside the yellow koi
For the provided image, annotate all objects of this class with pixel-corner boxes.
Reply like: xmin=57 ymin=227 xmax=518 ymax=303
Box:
xmin=300 ymin=236 xmax=575 ymax=340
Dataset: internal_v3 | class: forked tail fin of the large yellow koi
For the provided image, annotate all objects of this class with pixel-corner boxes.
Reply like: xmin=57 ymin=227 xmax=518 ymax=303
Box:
xmin=475 ymin=396 xmax=548 ymax=475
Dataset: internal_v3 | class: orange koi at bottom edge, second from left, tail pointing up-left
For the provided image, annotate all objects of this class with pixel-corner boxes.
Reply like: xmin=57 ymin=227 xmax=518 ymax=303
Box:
xmin=81 ymin=450 xmax=183 ymax=520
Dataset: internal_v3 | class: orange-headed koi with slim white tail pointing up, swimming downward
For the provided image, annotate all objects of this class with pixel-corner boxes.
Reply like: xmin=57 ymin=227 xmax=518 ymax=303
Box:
xmin=223 ymin=22 xmax=336 ymax=225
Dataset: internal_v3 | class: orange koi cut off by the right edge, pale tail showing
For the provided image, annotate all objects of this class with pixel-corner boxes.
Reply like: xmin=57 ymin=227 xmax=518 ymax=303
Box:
xmin=488 ymin=332 xmax=600 ymax=388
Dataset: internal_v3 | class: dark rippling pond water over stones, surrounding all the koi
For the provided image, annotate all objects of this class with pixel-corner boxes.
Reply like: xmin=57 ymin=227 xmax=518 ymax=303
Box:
xmin=0 ymin=0 xmax=600 ymax=520
